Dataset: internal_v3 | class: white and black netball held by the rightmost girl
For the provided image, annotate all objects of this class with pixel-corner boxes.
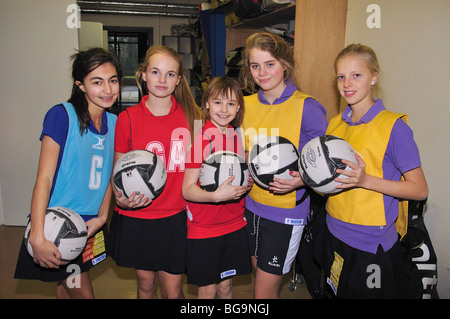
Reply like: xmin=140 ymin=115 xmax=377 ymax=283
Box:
xmin=300 ymin=135 xmax=357 ymax=194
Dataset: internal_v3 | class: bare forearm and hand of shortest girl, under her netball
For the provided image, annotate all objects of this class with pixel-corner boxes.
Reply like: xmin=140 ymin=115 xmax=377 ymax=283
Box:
xmin=181 ymin=168 xmax=248 ymax=203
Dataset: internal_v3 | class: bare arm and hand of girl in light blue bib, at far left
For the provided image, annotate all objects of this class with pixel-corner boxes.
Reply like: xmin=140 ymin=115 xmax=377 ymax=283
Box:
xmin=29 ymin=135 xmax=64 ymax=268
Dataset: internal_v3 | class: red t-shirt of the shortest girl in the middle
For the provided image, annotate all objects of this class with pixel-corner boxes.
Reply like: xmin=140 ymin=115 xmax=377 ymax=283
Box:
xmin=186 ymin=121 xmax=247 ymax=239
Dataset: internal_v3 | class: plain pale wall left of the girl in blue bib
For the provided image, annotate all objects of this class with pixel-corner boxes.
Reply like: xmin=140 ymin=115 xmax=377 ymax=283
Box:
xmin=0 ymin=0 xmax=78 ymax=225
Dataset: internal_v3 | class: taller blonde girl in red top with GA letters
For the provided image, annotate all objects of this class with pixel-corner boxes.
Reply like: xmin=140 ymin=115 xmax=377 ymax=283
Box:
xmin=110 ymin=46 xmax=202 ymax=299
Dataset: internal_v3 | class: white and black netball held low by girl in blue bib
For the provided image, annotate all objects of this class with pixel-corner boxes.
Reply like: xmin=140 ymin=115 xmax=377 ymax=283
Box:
xmin=24 ymin=207 xmax=87 ymax=262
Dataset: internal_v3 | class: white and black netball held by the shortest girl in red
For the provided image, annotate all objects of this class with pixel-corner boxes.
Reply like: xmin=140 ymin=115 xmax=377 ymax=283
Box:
xmin=199 ymin=151 xmax=248 ymax=192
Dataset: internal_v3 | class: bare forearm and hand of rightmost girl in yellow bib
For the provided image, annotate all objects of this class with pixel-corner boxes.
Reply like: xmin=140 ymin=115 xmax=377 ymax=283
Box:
xmin=336 ymin=153 xmax=428 ymax=200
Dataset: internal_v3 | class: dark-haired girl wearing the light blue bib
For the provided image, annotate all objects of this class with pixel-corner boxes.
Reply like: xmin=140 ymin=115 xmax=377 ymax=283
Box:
xmin=15 ymin=48 xmax=121 ymax=298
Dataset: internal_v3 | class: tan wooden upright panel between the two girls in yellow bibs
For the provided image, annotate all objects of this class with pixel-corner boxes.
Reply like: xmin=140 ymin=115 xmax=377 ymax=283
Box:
xmin=294 ymin=0 xmax=347 ymax=119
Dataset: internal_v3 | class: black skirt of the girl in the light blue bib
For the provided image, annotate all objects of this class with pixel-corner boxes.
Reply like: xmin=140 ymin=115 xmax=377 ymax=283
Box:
xmin=14 ymin=224 xmax=108 ymax=282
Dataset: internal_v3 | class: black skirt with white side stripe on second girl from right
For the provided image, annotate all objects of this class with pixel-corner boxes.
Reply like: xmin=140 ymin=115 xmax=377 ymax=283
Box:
xmin=245 ymin=209 xmax=304 ymax=275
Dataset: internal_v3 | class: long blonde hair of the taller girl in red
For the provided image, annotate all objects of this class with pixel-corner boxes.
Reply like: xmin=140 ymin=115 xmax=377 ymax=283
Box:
xmin=135 ymin=45 xmax=204 ymax=139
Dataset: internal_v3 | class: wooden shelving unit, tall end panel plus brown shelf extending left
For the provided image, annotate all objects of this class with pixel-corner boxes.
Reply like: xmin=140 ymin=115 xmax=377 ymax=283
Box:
xmin=226 ymin=0 xmax=347 ymax=119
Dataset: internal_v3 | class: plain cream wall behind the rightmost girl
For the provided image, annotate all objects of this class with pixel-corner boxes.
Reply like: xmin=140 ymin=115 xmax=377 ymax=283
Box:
xmin=345 ymin=0 xmax=450 ymax=298
